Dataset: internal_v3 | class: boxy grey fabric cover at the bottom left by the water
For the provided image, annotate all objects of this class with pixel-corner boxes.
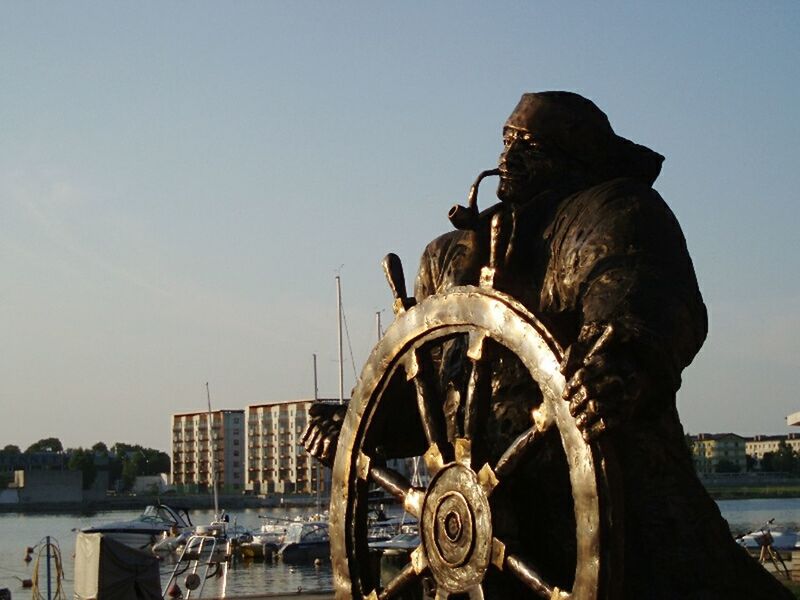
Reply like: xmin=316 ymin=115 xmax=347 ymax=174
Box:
xmin=75 ymin=533 xmax=162 ymax=600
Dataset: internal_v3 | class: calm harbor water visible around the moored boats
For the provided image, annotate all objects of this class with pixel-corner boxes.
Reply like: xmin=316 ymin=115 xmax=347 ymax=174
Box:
xmin=0 ymin=498 xmax=800 ymax=599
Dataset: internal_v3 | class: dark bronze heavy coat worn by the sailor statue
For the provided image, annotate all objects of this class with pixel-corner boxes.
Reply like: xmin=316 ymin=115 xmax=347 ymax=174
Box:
xmin=415 ymin=178 xmax=791 ymax=600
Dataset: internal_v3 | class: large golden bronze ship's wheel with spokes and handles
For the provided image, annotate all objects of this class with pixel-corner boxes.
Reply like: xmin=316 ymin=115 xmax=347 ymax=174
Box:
xmin=331 ymin=211 xmax=621 ymax=600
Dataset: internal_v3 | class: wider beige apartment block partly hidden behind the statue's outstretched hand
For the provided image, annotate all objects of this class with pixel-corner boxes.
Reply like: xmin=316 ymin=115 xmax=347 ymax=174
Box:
xmin=246 ymin=399 xmax=339 ymax=494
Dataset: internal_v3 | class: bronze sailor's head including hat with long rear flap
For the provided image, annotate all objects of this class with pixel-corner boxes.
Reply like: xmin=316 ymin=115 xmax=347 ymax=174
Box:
xmin=497 ymin=92 xmax=664 ymax=203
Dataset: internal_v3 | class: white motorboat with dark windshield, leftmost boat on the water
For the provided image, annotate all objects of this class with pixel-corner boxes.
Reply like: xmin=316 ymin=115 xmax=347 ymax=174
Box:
xmin=81 ymin=504 xmax=194 ymax=548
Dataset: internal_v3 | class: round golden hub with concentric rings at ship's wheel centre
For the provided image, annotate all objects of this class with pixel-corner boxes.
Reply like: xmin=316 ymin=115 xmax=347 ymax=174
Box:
xmin=420 ymin=463 xmax=492 ymax=593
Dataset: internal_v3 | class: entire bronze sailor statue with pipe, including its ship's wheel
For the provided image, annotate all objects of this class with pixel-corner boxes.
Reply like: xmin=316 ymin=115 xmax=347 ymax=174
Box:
xmin=304 ymin=92 xmax=792 ymax=600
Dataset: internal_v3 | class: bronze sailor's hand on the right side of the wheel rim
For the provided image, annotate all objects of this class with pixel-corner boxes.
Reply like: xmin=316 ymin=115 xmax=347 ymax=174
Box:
xmin=561 ymin=325 xmax=645 ymax=441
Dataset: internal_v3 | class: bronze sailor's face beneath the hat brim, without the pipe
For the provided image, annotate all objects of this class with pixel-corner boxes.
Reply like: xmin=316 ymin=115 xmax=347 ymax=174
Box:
xmin=497 ymin=125 xmax=563 ymax=203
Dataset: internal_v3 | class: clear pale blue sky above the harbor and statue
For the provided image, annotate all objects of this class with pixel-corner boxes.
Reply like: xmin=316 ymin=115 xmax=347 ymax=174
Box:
xmin=0 ymin=0 xmax=800 ymax=449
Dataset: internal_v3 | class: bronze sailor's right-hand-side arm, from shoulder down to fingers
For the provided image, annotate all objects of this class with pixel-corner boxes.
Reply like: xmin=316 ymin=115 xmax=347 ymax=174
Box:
xmin=554 ymin=183 xmax=707 ymax=438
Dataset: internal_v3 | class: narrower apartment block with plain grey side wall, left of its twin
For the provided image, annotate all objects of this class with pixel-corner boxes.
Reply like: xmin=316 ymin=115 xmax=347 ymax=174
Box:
xmin=172 ymin=409 xmax=245 ymax=492
